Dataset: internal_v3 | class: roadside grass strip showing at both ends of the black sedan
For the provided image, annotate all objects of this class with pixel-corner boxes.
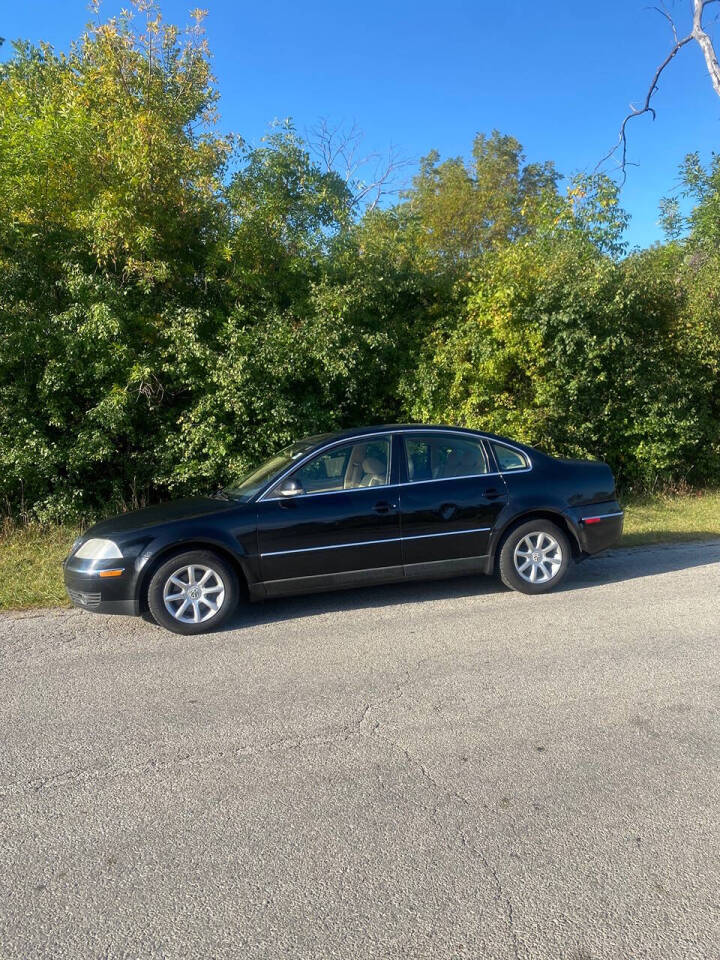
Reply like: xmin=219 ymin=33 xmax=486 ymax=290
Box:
xmin=0 ymin=490 xmax=720 ymax=610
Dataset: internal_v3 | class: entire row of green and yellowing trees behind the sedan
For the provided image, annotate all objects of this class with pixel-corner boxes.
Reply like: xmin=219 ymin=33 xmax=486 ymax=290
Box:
xmin=0 ymin=0 xmax=720 ymax=519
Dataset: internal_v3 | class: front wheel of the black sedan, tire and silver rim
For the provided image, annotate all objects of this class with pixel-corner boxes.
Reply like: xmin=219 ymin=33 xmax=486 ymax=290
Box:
xmin=148 ymin=550 xmax=240 ymax=634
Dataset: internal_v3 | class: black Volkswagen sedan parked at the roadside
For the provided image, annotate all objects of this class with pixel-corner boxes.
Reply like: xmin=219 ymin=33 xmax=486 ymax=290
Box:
xmin=64 ymin=425 xmax=623 ymax=633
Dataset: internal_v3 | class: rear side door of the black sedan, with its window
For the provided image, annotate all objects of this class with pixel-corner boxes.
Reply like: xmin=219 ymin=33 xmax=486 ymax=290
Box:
xmin=400 ymin=431 xmax=507 ymax=576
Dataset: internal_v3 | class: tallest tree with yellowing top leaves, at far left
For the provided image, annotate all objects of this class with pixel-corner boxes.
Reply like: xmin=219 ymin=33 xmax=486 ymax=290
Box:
xmin=0 ymin=4 xmax=231 ymax=516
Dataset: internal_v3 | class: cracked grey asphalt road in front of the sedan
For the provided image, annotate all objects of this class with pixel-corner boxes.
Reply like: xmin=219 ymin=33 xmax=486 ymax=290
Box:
xmin=0 ymin=541 xmax=720 ymax=960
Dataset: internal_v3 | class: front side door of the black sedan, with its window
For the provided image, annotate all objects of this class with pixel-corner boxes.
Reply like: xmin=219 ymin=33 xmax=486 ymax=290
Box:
xmin=258 ymin=434 xmax=403 ymax=594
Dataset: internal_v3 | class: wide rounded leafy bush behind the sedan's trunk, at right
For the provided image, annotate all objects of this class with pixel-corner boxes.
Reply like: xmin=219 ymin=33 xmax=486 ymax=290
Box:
xmin=408 ymin=237 xmax=720 ymax=489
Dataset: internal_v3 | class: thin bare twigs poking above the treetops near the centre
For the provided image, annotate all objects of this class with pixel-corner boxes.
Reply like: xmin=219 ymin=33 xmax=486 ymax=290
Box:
xmin=307 ymin=119 xmax=412 ymax=210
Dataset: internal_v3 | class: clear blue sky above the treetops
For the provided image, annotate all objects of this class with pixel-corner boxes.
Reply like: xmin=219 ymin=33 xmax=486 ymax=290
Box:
xmin=0 ymin=0 xmax=720 ymax=245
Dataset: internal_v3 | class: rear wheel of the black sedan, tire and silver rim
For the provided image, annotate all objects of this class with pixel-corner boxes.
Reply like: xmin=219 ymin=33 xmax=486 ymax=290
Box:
xmin=498 ymin=520 xmax=572 ymax=594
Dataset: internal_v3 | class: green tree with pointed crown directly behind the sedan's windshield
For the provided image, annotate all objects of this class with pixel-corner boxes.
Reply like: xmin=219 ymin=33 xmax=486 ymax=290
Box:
xmin=165 ymin=156 xmax=439 ymax=489
